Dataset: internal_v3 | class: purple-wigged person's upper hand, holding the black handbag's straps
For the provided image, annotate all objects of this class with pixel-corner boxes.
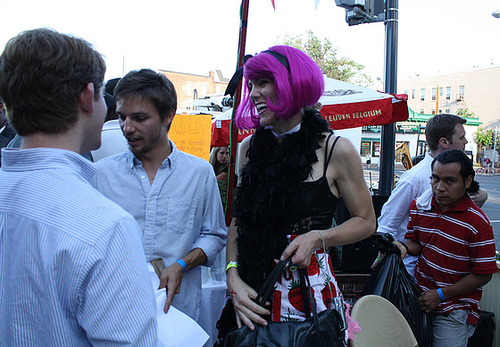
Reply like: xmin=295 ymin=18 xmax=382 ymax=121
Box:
xmin=280 ymin=230 xmax=321 ymax=268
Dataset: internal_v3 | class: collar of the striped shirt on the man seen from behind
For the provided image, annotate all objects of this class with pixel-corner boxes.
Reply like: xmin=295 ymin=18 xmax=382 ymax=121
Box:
xmin=2 ymin=147 xmax=96 ymax=181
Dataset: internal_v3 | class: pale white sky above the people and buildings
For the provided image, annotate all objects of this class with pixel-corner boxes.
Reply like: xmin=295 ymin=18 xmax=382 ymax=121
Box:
xmin=0 ymin=0 xmax=500 ymax=88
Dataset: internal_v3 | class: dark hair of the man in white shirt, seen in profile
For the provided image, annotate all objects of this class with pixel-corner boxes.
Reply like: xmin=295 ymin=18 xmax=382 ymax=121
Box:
xmin=425 ymin=113 xmax=467 ymax=151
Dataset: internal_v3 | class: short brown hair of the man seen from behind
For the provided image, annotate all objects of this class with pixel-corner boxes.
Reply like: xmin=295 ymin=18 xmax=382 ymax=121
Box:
xmin=0 ymin=29 xmax=106 ymax=136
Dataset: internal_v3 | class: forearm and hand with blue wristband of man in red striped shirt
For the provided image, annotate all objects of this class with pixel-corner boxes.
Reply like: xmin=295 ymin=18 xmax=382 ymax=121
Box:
xmin=418 ymin=274 xmax=492 ymax=313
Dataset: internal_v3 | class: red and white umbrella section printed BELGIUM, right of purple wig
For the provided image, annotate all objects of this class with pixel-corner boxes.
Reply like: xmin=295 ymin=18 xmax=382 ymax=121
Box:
xmin=319 ymin=77 xmax=408 ymax=129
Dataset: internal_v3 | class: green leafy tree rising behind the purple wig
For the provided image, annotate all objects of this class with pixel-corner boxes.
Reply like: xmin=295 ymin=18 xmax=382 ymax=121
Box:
xmin=278 ymin=30 xmax=372 ymax=86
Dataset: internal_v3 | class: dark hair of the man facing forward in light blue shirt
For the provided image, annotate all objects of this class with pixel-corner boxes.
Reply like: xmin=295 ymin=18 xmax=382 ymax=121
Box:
xmin=114 ymin=69 xmax=177 ymax=121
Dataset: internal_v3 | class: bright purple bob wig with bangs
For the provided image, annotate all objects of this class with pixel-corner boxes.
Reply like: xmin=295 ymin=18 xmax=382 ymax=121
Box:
xmin=235 ymin=46 xmax=325 ymax=129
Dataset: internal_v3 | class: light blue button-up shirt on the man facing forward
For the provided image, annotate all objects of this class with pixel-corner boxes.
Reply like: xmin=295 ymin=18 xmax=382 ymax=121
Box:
xmin=92 ymin=142 xmax=227 ymax=320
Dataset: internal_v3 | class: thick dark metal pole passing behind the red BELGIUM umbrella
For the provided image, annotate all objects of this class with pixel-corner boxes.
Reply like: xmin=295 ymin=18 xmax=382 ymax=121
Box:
xmin=379 ymin=0 xmax=398 ymax=196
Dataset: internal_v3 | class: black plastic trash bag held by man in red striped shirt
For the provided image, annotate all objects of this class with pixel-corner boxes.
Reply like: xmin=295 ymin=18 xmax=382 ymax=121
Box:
xmin=361 ymin=234 xmax=432 ymax=347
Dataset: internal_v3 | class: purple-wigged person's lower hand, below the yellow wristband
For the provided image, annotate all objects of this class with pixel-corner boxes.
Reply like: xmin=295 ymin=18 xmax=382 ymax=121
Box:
xmin=227 ymin=269 xmax=271 ymax=331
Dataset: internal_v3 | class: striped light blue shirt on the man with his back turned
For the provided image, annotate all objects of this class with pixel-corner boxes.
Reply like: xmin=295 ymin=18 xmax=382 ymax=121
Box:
xmin=0 ymin=148 xmax=157 ymax=347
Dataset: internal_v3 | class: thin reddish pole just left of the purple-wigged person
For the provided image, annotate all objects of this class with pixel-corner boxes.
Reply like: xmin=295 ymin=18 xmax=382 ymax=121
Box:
xmin=226 ymin=0 xmax=250 ymax=226
